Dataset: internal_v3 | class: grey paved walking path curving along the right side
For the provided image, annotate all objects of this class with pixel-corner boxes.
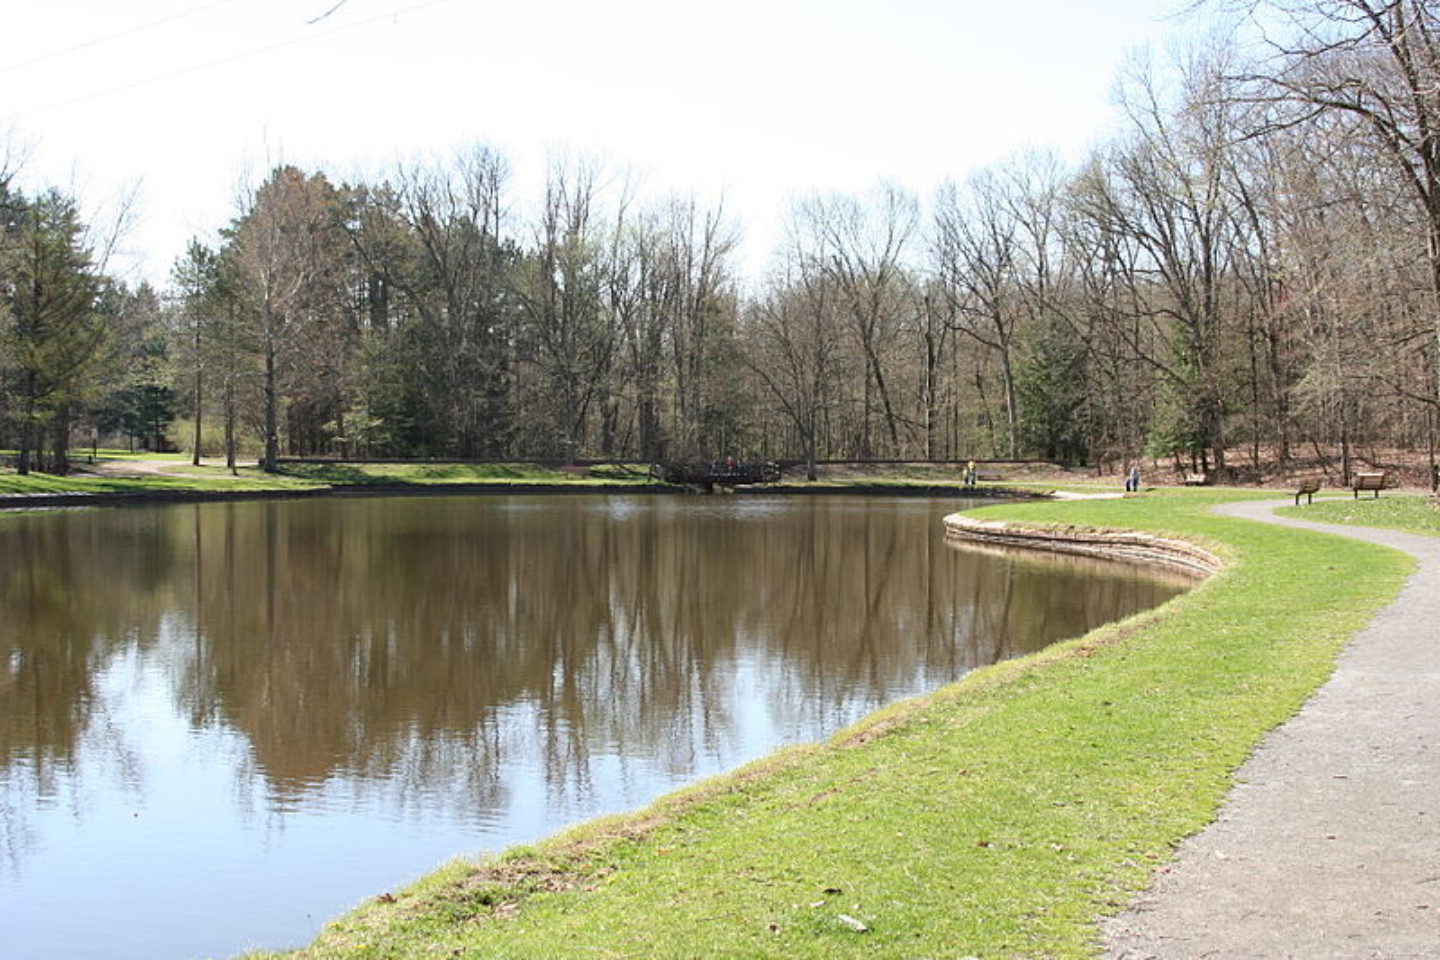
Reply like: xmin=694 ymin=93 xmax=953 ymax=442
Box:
xmin=1103 ymin=502 xmax=1440 ymax=960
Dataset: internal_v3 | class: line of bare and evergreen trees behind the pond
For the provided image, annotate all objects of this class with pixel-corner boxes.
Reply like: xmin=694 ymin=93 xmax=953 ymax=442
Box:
xmin=0 ymin=0 xmax=1440 ymax=478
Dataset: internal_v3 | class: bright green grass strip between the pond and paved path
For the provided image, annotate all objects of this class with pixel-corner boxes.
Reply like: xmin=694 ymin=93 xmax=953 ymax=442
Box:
xmin=250 ymin=491 xmax=1411 ymax=957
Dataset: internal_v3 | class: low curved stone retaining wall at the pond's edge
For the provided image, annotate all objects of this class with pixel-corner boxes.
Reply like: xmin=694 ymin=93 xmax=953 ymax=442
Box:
xmin=945 ymin=514 xmax=1224 ymax=579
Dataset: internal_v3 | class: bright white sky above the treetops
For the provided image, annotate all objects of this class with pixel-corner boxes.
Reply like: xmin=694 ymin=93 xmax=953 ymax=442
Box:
xmin=0 ymin=0 xmax=1185 ymax=279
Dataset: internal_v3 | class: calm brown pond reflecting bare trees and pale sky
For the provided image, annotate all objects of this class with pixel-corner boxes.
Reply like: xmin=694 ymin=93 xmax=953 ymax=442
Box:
xmin=0 ymin=495 xmax=1181 ymax=960
